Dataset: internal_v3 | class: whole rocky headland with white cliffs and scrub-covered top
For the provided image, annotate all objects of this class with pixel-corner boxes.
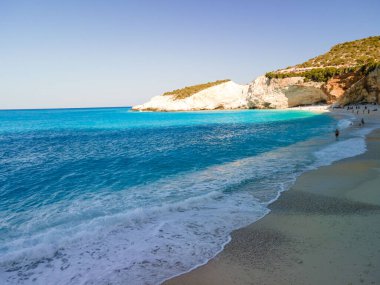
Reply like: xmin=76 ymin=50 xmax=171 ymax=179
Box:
xmin=133 ymin=36 xmax=380 ymax=111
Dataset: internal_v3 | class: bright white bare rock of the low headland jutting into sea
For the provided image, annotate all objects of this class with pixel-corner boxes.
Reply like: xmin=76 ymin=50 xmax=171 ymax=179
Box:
xmin=132 ymin=81 xmax=248 ymax=111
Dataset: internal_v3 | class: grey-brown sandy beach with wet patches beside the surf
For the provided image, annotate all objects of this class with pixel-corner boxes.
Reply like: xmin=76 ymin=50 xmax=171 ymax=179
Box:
xmin=164 ymin=106 xmax=380 ymax=285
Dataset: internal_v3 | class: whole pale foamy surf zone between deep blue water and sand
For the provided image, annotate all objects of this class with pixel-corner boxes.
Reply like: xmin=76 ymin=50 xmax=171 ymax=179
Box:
xmin=0 ymin=123 xmax=378 ymax=285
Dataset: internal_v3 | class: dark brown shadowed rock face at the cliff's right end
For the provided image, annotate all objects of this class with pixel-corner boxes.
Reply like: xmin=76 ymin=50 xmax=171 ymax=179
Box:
xmin=338 ymin=68 xmax=380 ymax=105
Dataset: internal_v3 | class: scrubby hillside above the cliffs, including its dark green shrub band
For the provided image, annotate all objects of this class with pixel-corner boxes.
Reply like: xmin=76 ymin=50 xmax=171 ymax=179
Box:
xmin=265 ymin=36 xmax=380 ymax=82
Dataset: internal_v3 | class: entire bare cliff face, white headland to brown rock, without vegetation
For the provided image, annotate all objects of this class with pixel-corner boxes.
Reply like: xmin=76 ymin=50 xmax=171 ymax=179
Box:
xmin=133 ymin=69 xmax=380 ymax=111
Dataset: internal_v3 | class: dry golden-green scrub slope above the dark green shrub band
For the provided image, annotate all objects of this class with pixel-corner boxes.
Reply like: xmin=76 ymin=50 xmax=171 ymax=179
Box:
xmin=295 ymin=36 xmax=380 ymax=68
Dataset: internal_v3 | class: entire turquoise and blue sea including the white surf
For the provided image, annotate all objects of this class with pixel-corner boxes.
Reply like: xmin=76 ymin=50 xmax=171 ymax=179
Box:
xmin=0 ymin=108 xmax=365 ymax=285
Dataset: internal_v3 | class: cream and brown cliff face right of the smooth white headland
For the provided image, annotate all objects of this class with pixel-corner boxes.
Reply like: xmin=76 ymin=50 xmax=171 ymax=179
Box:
xmin=247 ymin=68 xmax=380 ymax=109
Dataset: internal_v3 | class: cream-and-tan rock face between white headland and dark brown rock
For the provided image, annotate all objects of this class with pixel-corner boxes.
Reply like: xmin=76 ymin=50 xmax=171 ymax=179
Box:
xmin=247 ymin=76 xmax=327 ymax=109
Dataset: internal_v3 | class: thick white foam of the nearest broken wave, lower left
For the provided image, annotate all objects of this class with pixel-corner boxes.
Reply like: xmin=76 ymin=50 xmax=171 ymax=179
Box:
xmin=0 ymin=192 xmax=268 ymax=284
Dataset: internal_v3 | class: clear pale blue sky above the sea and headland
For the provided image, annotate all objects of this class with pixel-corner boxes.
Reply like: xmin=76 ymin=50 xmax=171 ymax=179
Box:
xmin=0 ymin=0 xmax=380 ymax=109
